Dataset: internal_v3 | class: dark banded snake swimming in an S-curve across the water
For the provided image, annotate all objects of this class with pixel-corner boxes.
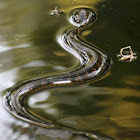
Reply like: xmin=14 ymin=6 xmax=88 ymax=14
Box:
xmin=4 ymin=8 xmax=112 ymax=137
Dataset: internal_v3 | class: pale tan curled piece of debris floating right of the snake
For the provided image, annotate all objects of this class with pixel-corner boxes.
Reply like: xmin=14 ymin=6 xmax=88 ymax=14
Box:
xmin=117 ymin=46 xmax=137 ymax=62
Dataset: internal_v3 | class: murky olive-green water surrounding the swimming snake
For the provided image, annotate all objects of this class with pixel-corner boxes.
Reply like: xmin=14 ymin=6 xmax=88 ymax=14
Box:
xmin=0 ymin=0 xmax=140 ymax=140
